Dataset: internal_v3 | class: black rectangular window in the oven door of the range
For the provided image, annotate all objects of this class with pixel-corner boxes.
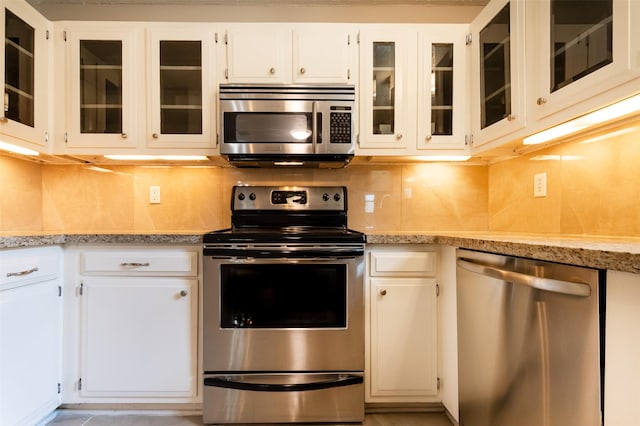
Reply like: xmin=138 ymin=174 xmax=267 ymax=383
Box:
xmin=220 ymin=263 xmax=347 ymax=328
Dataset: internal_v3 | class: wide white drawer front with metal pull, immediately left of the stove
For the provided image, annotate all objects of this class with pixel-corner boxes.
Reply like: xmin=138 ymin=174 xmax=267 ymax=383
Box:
xmin=80 ymin=250 xmax=198 ymax=276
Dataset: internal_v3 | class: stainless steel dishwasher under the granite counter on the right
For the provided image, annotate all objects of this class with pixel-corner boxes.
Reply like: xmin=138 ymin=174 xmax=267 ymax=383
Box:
xmin=457 ymin=250 xmax=605 ymax=426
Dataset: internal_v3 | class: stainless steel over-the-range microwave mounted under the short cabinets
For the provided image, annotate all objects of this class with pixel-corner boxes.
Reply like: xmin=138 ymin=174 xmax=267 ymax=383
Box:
xmin=220 ymin=84 xmax=355 ymax=168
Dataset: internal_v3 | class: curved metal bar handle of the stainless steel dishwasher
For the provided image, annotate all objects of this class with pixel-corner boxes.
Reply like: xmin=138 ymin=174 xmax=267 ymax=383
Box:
xmin=457 ymin=258 xmax=591 ymax=297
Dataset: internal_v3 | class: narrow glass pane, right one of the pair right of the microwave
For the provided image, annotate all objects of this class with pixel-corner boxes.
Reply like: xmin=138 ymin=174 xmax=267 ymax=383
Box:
xmin=430 ymin=43 xmax=453 ymax=135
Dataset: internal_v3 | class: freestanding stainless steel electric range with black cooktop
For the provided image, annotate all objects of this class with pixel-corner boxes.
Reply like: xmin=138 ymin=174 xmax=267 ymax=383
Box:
xmin=203 ymin=186 xmax=365 ymax=423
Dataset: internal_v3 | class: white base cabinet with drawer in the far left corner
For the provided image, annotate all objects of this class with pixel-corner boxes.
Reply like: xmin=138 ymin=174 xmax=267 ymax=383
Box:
xmin=0 ymin=247 xmax=62 ymax=425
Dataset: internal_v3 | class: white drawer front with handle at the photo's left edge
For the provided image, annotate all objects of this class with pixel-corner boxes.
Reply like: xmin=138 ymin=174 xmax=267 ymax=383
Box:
xmin=0 ymin=247 xmax=60 ymax=290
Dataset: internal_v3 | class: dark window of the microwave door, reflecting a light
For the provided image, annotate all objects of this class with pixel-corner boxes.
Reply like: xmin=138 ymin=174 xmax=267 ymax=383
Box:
xmin=224 ymin=112 xmax=322 ymax=144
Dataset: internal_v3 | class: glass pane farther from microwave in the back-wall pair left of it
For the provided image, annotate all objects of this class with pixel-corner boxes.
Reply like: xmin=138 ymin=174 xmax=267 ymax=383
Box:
xmin=80 ymin=40 xmax=122 ymax=133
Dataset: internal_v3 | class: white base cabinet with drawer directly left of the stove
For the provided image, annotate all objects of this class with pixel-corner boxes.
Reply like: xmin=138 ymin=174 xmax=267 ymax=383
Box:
xmin=65 ymin=246 xmax=199 ymax=403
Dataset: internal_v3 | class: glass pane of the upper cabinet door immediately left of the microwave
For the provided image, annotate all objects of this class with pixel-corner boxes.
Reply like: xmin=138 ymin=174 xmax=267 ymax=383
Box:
xmin=160 ymin=41 xmax=202 ymax=134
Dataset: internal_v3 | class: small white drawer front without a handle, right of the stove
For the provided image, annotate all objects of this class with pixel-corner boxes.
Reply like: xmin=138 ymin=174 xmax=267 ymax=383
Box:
xmin=370 ymin=251 xmax=436 ymax=276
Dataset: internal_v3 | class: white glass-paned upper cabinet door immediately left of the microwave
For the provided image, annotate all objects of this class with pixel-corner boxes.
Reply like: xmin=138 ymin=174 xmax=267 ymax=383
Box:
xmin=147 ymin=29 xmax=215 ymax=148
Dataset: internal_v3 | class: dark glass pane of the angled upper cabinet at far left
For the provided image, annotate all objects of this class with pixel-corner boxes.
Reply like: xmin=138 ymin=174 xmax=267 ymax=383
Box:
xmin=4 ymin=10 xmax=35 ymax=127
